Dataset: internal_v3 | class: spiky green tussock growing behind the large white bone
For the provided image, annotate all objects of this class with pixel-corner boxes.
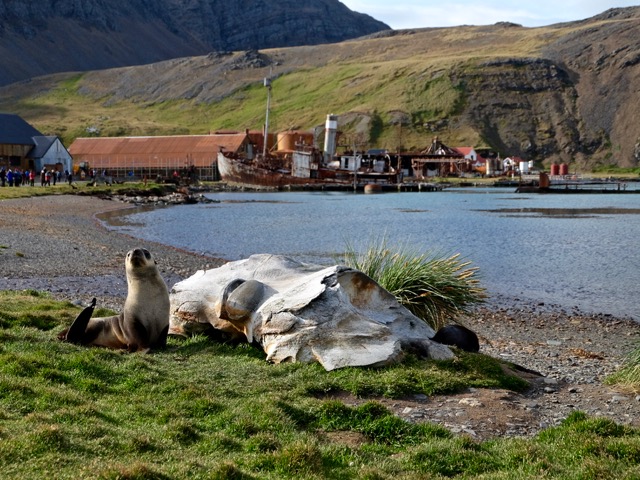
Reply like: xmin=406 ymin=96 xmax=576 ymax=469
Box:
xmin=342 ymin=238 xmax=485 ymax=330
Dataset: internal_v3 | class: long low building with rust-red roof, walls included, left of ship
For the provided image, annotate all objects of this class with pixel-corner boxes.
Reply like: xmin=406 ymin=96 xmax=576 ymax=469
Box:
xmin=69 ymin=132 xmax=251 ymax=180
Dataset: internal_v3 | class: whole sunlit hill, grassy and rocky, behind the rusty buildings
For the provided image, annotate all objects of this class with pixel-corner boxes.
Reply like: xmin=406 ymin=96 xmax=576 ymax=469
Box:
xmin=0 ymin=7 xmax=640 ymax=169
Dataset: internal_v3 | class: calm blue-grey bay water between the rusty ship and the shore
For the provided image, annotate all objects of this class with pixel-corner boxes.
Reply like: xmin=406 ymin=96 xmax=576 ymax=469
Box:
xmin=102 ymin=189 xmax=640 ymax=319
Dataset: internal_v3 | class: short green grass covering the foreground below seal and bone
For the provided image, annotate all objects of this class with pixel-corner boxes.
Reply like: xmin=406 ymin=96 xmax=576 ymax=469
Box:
xmin=0 ymin=291 xmax=640 ymax=479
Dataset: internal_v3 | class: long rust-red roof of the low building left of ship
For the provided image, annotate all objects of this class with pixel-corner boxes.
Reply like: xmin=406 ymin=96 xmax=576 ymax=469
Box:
xmin=69 ymin=132 xmax=247 ymax=169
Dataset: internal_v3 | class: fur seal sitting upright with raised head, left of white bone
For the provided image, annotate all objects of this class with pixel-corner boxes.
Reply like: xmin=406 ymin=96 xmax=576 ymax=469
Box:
xmin=58 ymin=248 xmax=169 ymax=352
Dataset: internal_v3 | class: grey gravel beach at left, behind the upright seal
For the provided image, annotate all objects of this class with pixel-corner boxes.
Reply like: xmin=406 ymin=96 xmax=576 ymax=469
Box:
xmin=0 ymin=195 xmax=225 ymax=308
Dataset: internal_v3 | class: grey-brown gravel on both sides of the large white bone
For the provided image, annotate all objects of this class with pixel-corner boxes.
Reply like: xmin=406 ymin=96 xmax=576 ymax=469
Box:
xmin=0 ymin=195 xmax=640 ymax=439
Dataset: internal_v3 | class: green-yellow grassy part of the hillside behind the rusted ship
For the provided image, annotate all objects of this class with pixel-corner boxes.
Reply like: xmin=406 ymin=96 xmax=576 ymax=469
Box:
xmin=0 ymin=23 xmax=550 ymax=147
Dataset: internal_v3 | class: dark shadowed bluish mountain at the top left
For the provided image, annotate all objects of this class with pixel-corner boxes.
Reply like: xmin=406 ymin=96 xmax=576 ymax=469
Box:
xmin=0 ymin=0 xmax=389 ymax=85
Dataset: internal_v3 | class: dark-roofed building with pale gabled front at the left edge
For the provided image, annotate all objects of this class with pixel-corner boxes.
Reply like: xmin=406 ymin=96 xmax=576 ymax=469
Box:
xmin=0 ymin=113 xmax=72 ymax=172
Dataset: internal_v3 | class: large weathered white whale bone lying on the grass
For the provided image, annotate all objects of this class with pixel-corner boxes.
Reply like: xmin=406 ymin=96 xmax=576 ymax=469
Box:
xmin=169 ymin=254 xmax=453 ymax=370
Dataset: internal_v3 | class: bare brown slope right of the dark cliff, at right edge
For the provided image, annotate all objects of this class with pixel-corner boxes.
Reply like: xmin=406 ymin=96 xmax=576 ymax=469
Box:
xmin=542 ymin=7 xmax=640 ymax=166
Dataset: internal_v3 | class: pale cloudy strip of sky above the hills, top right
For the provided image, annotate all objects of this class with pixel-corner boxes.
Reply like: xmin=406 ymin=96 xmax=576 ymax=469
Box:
xmin=341 ymin=0 xmax=640 ymax=29
